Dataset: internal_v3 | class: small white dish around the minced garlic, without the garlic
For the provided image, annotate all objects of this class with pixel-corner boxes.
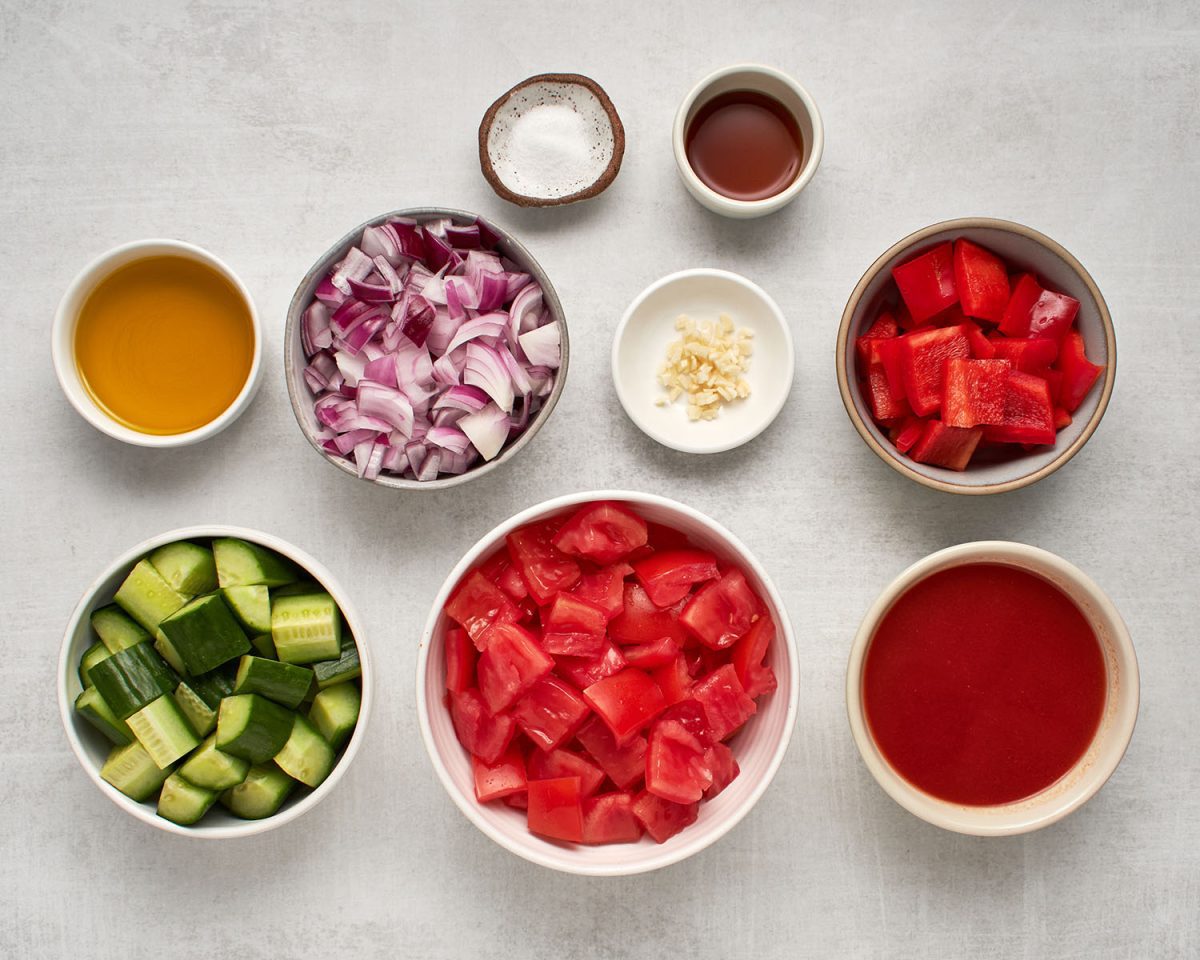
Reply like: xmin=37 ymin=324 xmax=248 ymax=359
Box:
xmin=612 ymin=269 xmax=796 ymax=454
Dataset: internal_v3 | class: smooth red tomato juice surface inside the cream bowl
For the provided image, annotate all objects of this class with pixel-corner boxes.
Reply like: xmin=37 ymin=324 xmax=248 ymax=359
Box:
xmin=863 ymin=564 xmax=1108 ymax=805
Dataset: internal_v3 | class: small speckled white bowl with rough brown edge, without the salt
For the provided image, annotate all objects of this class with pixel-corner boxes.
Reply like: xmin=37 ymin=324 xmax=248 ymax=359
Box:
xmin=479 ymin=73 xmax=625 ymax=206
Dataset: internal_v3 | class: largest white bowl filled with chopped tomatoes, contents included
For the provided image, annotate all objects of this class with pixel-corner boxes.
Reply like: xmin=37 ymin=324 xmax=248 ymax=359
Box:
xmin=418 ymin=491 xmax=798 ymax=876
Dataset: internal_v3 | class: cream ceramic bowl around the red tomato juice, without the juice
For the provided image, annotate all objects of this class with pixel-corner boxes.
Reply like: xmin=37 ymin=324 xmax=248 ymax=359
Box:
xmin=846 ymin=540 xmax=1139 ymax=836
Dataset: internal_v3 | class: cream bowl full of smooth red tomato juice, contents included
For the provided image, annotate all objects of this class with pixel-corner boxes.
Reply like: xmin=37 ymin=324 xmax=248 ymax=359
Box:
xmin=846 ymin=541 xmax=1139 ymax=836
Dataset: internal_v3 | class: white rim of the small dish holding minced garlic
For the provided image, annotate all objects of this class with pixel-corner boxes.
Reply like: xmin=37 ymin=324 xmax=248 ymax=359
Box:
xmin=610 ymin=266 xmax=796 ymax=455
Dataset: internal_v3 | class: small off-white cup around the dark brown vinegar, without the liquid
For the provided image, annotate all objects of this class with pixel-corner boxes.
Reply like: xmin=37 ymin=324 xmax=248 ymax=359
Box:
xmin=671 ymin=64 xmax=824 ymax=220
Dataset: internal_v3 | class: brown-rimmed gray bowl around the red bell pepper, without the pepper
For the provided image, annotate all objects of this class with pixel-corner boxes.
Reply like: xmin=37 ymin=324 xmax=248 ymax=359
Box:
xmin=835 ymin=217 xmax=1117 ymax=494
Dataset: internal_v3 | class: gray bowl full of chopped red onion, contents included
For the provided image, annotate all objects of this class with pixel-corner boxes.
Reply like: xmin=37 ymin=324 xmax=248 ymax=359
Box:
xmin=283 ymin=208 xmax=569 ymax=490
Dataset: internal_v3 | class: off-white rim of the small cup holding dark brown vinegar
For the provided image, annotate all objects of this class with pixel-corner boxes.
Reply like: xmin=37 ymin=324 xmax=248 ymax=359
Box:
xmin=671 ymin=61 xmax=824 ymax=218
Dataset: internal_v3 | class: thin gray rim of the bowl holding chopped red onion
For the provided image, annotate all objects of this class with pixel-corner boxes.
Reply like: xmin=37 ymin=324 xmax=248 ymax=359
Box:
xmin=283 ymin=206 xmax=571 ymax=490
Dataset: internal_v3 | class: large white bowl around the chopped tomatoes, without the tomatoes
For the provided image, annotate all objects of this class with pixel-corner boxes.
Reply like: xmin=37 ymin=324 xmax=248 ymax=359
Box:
xmin=416 ymin=490 xmax=799 ymax=876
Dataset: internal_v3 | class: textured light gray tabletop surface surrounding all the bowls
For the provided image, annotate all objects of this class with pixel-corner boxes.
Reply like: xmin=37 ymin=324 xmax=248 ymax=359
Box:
xmin=0 ymin=0 xmax=1200 ymax=960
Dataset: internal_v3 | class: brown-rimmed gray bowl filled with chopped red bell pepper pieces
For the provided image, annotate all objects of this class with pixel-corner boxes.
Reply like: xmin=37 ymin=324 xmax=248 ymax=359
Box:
xmin=836 ymin=217 xmax=1116 ymax=494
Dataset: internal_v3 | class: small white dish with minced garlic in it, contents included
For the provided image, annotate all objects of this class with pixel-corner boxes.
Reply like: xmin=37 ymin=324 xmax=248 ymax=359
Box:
xmin=612 ymin=268 xmax=796 ymax=454
